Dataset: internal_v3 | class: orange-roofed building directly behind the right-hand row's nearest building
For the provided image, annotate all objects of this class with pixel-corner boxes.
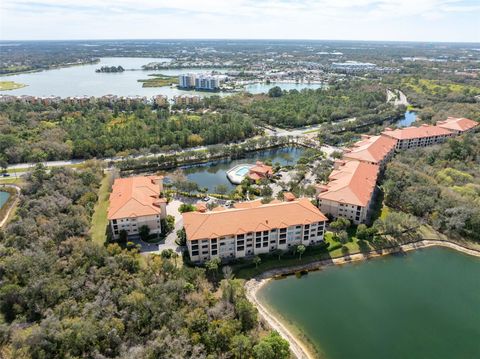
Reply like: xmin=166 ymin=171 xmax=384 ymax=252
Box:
xmin=343 ymin=135 xmax=397 ymax=168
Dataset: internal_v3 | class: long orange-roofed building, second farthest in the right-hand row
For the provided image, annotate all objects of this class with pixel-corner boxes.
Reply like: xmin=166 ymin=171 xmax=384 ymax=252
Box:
xmin=382 ymin=124 xmax=455 ymax=150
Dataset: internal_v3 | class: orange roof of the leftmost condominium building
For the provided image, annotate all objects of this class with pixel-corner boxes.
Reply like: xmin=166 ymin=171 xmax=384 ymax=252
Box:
xmin=108 ymin=176 xmax=165 ymax=220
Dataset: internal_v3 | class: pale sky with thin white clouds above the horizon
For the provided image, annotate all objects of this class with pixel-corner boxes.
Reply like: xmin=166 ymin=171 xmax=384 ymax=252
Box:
xmin=0 ymin=0 xmax=480 ymax=42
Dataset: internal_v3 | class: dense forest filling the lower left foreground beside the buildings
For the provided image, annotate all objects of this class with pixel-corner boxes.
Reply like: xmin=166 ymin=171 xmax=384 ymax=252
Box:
xmin=0 ymin=163 xmax=290 ymax=359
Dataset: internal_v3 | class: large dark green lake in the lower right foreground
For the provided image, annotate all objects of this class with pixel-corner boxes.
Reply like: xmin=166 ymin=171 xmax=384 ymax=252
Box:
xmin=258 ymin=248 xmax=480 ymax=359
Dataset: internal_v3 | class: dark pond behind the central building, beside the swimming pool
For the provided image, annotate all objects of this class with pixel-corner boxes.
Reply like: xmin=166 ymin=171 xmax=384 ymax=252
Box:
xmin=165 ymin=147 xmax=305 ymax=192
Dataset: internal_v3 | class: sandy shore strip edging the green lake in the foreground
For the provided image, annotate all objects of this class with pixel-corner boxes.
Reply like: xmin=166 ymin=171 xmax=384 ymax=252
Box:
xmin=245 ymin=240 xmax=480 ymax=359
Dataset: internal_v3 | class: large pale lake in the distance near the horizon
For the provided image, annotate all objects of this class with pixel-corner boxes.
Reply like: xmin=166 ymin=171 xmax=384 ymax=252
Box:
xmin=0 ymin=57 xmax=230 ymax=98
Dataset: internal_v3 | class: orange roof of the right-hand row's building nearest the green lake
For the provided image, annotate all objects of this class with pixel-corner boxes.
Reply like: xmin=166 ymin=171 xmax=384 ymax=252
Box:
xmin=318 ymin=160 xmax=379 ymax=207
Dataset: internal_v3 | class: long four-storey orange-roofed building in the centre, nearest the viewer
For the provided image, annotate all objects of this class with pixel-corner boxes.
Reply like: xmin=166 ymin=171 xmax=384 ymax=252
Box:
xmin=183 ymin=197 xmax=327 ymax=262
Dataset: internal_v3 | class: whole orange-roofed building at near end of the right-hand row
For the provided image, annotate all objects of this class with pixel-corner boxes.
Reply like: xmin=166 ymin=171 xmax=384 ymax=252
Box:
xmin=318 ymin=160 xmax=379 ymax=224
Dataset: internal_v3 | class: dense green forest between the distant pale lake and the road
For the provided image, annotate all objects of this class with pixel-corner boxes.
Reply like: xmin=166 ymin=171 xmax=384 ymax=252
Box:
xmin=0 ymin=103 xmax=258 ymax=163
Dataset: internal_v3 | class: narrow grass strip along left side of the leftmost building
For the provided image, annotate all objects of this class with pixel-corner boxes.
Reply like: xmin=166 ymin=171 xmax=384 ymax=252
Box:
xmin=90 ymin=173 xmax=112 ymax=245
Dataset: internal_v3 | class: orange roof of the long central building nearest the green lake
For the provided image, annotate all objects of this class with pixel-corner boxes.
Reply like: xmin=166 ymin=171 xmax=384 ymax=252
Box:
xmin=183 ymin=198 xmax=327 ymax=240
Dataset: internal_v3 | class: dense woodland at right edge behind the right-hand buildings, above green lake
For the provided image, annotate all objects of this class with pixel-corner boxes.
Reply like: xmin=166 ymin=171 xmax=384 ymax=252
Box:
xmin=383 ymin=133 xmax=480 ymax=241
